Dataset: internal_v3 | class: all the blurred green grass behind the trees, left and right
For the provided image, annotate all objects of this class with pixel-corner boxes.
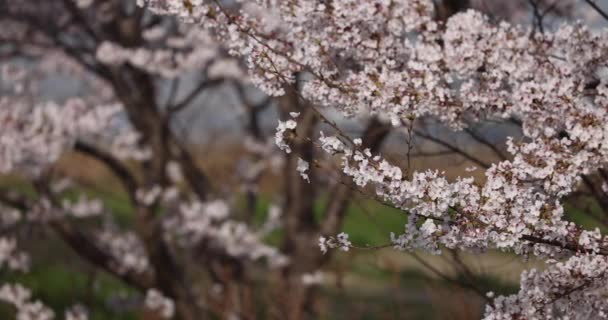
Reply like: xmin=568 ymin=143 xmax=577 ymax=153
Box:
xmin=0 ymin=178 xmax=597 ymax=320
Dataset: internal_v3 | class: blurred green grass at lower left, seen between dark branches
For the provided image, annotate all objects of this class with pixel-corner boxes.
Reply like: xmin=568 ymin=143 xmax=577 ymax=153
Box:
xmin=0 ymin=176 xmax=137 ymax=320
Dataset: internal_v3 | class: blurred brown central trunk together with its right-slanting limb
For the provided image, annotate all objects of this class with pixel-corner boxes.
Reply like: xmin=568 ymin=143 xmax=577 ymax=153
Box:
xmin=278 ymin=83 xmax=391 ymax=320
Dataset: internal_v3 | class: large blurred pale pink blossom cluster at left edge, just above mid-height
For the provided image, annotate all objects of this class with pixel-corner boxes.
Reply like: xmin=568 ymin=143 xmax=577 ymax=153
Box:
xmin=0 ymin=97 xmax=120 ymax=174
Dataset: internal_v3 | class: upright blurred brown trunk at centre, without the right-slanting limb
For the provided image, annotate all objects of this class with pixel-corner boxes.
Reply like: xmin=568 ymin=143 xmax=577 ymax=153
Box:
xmin=279 ymin=84 xmax=319 ymax=320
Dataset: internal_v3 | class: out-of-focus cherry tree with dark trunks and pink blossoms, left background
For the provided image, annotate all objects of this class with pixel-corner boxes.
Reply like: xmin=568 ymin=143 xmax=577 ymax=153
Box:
xmin=0 ymin=0 xmax=404 ymax=319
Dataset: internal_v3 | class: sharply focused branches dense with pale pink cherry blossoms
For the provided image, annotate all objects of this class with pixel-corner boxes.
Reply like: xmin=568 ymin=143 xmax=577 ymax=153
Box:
xmin=141 ymin=0 xmax=608 ymax=319
